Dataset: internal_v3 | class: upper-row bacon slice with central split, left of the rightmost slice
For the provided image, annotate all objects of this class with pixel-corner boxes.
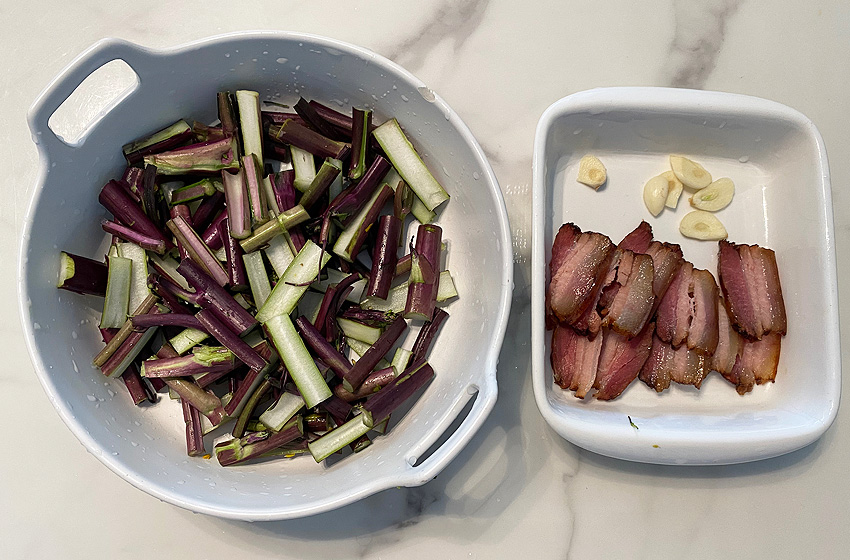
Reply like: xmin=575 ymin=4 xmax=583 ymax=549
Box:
xmin=656 ymin=261 xmax=718 ymax=356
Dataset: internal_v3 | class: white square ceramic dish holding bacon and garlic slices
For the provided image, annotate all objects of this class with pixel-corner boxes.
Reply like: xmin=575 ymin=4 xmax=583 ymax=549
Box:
xmin=532 ymin=88 xmax=841 ymax=465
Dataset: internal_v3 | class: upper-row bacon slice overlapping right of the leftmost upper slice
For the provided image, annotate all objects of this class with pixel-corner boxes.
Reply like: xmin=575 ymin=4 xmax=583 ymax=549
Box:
xmin=601 ymin=249 xmax=655 ymax=338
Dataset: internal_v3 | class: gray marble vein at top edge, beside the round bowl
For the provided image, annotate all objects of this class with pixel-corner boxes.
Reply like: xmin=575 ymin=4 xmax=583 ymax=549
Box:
xmin=383 ymin=0 xmax=490 ymax=71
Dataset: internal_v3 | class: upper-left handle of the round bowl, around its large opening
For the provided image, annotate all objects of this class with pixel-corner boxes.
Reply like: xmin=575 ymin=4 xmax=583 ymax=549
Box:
xmin=27 ymin=39 xmax=156 ymax=155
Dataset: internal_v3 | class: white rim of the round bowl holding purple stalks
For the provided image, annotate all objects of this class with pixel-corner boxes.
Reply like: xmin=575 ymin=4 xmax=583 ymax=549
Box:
xmin=17 ymin=30 xmax=514 ymax=521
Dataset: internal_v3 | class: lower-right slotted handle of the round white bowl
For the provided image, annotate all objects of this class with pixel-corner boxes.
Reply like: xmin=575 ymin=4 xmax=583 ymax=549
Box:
xmin=405 ymin=376 xmax=498 ymax=486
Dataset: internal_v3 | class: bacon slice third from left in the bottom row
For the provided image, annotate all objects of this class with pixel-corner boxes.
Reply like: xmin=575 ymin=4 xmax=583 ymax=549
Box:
xmin=639 ymin=336 xmax=711 ymax=393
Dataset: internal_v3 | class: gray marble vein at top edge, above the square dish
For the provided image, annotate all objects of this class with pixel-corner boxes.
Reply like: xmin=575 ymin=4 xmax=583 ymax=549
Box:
xmin=664 ymin=0 xmax=742 ymax=89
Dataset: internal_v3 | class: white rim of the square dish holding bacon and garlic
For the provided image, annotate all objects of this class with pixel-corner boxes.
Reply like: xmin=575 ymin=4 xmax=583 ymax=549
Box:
xmin=531 ymin=87 xmax=841 ymax=466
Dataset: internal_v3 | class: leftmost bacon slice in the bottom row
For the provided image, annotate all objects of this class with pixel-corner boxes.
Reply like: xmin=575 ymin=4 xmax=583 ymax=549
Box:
xmin=550 ymin=325 xmax=602 ymax=399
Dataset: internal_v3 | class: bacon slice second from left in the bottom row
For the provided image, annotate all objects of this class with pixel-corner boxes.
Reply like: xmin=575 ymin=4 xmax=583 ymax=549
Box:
xmin=593 ymin=323 xmax=654 ymax=401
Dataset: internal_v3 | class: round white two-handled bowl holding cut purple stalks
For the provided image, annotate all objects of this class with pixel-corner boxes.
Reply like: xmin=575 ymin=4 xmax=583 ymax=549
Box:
xmin=19 ymin=32 xmax=512 ymax=520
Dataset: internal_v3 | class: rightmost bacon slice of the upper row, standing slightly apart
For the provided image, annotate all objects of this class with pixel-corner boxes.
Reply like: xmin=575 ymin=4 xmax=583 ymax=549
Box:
xmin=717 ymin=240 xmax=787 ymax=340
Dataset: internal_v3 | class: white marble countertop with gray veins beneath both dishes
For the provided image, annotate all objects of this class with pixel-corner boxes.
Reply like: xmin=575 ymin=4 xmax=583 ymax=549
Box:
xmin=0 ymin=0 xmax=850 ymax=559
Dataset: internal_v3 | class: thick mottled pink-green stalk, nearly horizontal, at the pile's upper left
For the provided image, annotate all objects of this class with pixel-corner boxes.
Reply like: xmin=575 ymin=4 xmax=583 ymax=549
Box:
xmin=144 ymin=137 xmax=239 ymax=175
